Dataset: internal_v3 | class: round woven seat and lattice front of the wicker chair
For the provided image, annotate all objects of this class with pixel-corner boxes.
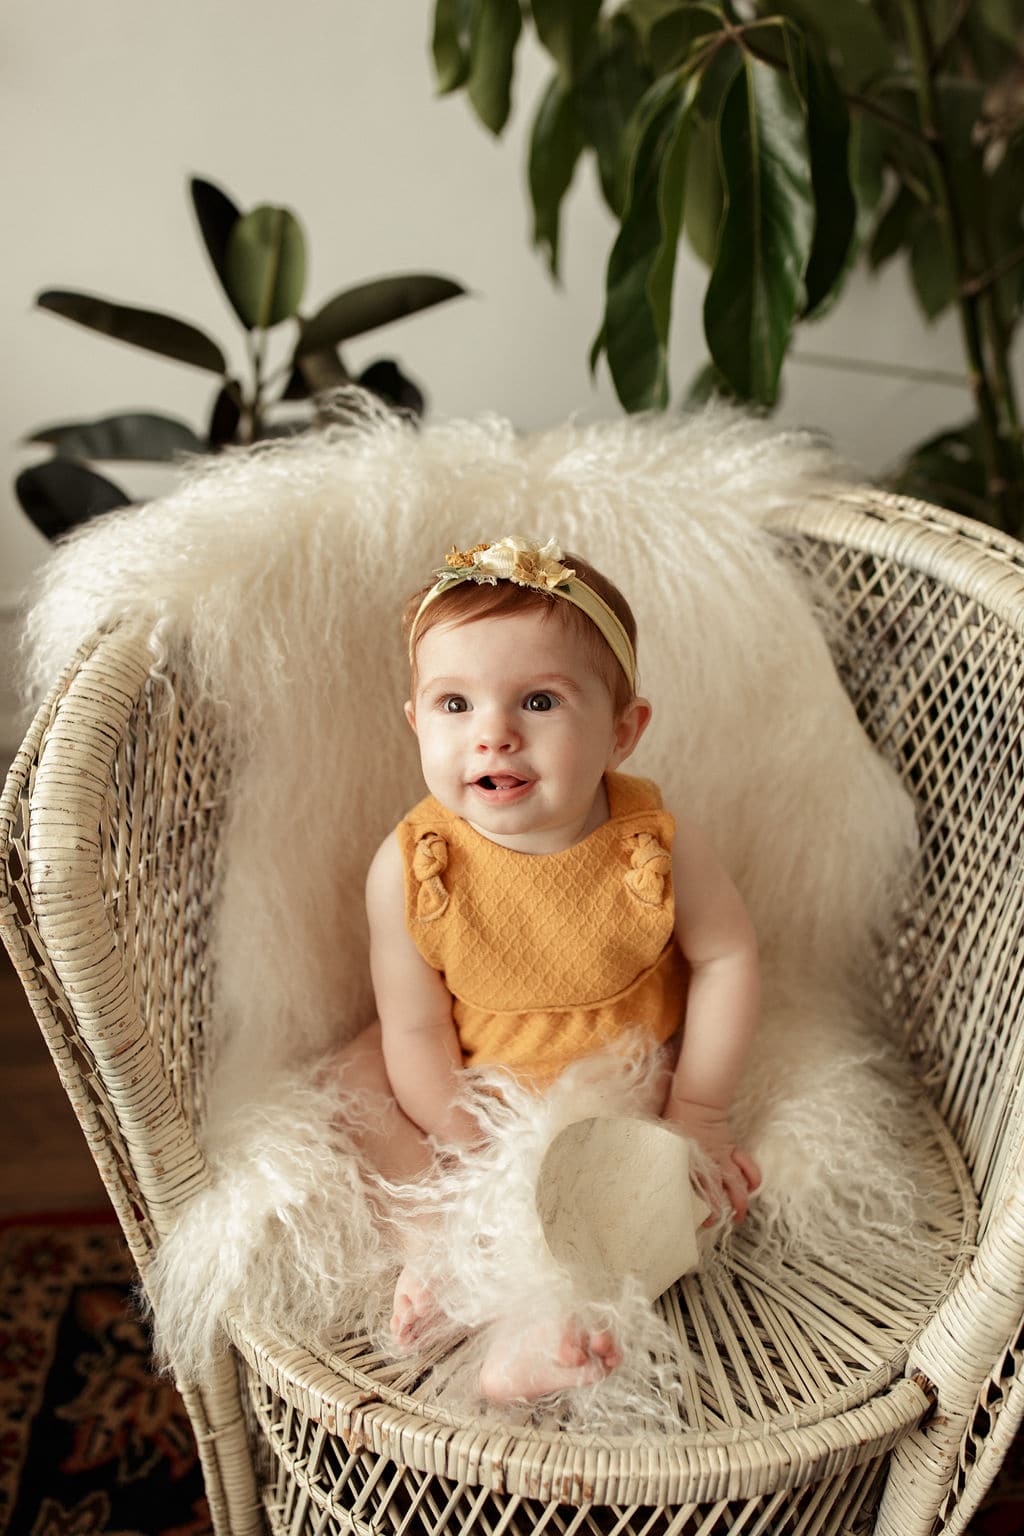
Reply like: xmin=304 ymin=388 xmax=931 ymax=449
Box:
xmin=221 ymin=1115 xmax=976 ymax=1517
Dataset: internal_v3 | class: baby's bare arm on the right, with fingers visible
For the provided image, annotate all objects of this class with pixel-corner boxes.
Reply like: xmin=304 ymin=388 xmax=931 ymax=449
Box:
xmin=665 ymin=819 xmax=760 ymax=1221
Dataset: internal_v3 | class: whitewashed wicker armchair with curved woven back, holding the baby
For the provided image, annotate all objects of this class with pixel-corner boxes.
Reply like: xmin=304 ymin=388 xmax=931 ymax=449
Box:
xmin=0 ymin=492 xmax=1024 ymax=1536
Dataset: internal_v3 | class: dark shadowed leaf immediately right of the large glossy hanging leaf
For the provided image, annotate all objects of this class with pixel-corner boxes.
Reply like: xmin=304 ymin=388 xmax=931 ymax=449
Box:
xmin=804 ymin=49 xmax=857 ymax=315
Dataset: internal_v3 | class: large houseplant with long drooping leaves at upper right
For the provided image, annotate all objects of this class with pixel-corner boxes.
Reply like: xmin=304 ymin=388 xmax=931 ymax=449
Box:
xmin=433 ymin=0 xmax=1024 ymax=536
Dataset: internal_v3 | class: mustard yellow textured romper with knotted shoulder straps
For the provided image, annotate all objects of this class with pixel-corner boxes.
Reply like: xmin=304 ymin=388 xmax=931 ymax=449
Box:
xmin=398 ymin=773 xmax=686 ymax=1086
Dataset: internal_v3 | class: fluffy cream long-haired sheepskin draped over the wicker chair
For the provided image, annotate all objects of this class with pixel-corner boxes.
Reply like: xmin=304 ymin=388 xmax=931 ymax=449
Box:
xmin=28 ymin=407 xmax=939 ymax=1422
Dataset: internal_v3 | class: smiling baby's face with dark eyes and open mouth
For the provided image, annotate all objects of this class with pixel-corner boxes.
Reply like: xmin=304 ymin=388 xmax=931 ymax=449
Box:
xmin=405 ymin=611 xmax=636 ymax=852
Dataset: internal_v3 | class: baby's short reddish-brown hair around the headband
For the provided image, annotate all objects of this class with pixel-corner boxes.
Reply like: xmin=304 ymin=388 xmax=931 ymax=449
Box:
xmin=402 ymin=550 xmax=637 ymax=714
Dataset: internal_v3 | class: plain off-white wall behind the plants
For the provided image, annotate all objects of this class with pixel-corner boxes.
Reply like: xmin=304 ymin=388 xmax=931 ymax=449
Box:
xmin=0 ymin=0 xmax=1000 ymax=746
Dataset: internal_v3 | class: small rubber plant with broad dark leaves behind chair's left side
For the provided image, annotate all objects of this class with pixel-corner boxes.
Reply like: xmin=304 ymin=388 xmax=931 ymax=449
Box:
xmin=15 ymin=177 xmax=465 ymax=538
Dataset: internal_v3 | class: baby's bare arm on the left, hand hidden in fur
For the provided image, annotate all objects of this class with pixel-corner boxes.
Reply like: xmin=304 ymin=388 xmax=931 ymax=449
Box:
xmin=367 ymin=833 xmax=476 ymax=1141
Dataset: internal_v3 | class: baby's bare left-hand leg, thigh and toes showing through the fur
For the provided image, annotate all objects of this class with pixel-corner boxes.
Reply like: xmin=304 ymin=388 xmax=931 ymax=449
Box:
xmin=323 ymin=1025 xmax=441 ymax=1350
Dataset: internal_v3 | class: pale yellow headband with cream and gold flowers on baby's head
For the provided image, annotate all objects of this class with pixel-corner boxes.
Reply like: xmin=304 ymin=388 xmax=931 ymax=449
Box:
xmin=408 ymin=539 xmax=637 ymax=688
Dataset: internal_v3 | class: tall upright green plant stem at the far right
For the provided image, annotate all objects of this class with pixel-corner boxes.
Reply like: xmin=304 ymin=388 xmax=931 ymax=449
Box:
xmin=900 ymin=0 xmax=1016 ymax=527
